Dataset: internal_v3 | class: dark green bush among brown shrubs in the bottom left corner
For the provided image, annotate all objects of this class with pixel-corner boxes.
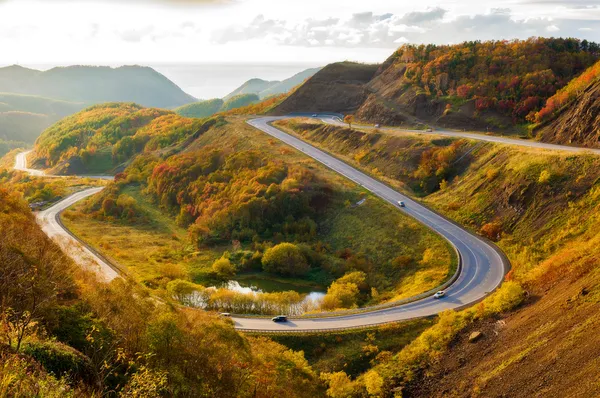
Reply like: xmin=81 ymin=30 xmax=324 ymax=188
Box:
xmin=23 ymin=341 xmax=91 ymax=380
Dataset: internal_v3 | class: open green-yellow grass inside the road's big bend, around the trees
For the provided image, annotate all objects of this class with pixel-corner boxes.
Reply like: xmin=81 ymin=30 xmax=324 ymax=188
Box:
xmin=63 ymin=118 xmax=453 ymax=302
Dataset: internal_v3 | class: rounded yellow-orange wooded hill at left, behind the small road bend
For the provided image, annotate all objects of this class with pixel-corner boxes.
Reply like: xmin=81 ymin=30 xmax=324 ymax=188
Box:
xmin=31 ymin=103 xmax=214 ymax=174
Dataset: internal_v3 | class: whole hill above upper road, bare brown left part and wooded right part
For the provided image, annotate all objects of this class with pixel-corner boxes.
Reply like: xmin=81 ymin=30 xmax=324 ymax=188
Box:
xmin=276 ymin=38 xmax=600 ymax=131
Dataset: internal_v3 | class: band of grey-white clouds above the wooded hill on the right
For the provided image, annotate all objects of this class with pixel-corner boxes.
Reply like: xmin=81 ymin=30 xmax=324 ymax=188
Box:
xmin=212 ymin=8 xmax=600 ymax=48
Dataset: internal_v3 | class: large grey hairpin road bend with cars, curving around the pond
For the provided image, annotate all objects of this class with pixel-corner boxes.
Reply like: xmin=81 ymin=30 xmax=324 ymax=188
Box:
xmin=232 ymin=117 xmax=509 ymax=332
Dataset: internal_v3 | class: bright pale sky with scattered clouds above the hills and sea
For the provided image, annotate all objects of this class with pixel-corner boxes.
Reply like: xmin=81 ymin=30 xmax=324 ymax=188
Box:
xmin=0 ymin=0 xmax=600 ymax=65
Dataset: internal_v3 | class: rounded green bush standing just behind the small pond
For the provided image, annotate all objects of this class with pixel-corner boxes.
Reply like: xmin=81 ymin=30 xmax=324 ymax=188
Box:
xmin=262 ymin=242 xmax=310 ymax=276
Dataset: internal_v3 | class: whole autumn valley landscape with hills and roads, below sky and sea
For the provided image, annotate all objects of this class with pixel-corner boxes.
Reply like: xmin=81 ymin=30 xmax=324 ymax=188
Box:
xmin=0 ymin=31 xmax=600 ymax=398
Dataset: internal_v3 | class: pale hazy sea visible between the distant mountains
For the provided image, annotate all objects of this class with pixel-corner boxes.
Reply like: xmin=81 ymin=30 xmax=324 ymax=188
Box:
xmin=149 ymin=63 xmax=322 ymax=99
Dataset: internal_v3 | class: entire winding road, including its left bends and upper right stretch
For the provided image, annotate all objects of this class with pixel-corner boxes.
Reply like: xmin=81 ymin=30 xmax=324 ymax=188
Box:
xmin=15 ymin=114 xmax=584 ymax=332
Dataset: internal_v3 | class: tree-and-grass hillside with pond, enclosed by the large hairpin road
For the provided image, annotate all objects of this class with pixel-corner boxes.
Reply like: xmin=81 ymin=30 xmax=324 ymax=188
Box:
xmin=64 ymin=118 xmax=452 ymax=314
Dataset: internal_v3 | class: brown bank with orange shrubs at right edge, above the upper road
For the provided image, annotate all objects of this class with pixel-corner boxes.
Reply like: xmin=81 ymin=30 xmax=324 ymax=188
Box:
xmin=537 ymin=80 xmax=600 ymax=148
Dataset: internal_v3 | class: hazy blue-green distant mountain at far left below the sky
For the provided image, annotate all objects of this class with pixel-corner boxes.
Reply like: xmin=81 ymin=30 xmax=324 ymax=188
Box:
xmin=0 ymin=66 xmax=196 ymax=108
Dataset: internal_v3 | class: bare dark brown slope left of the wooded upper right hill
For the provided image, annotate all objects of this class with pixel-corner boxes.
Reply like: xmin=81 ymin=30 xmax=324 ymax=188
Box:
xmin=273 ymin=62 xmax=378 ymax=115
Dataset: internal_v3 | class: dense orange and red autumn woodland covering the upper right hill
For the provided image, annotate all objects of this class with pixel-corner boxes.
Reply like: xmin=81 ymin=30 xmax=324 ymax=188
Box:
xmin=386 ymin=38 xmax=600 ymax=123
